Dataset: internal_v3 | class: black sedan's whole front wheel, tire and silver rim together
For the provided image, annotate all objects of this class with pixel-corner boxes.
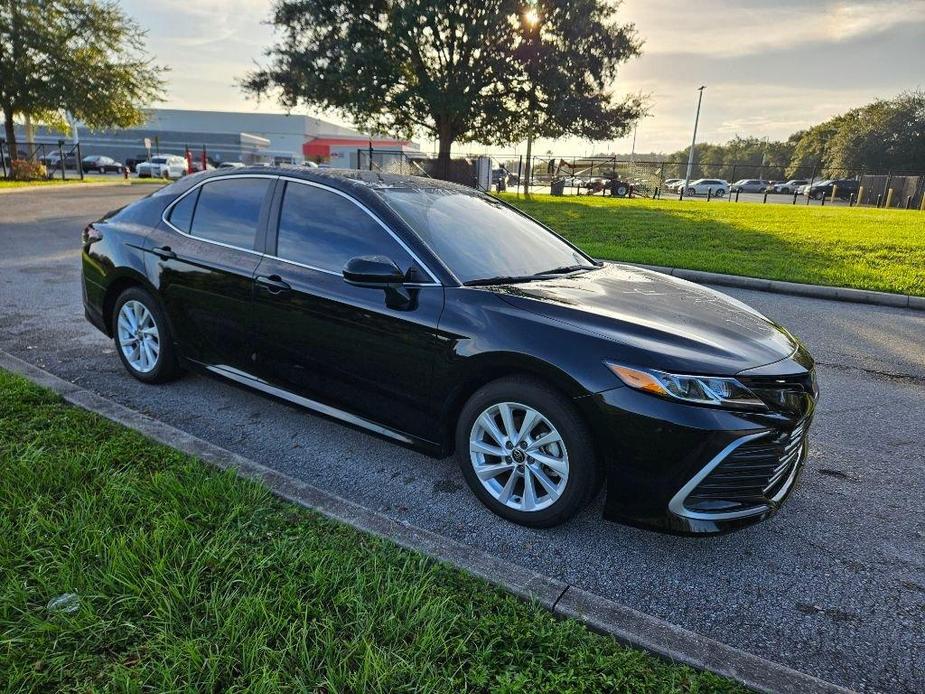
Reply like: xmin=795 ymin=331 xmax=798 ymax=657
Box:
xmin=456 ymin=377 xmax=601 ymax=528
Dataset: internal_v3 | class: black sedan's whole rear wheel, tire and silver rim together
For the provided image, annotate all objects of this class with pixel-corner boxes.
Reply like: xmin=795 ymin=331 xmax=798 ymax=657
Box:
xmin=112 ymin=287 xmax=180 ymax=383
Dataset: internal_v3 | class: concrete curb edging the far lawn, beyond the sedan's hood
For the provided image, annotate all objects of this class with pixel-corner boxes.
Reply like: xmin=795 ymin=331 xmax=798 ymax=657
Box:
xmin=626 ymin=263 xmax=925 ymax=311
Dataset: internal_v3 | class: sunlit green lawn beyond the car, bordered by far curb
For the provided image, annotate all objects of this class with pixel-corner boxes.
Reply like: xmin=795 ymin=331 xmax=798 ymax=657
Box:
xmin=501 ymin=194 xmax=925 ymax=296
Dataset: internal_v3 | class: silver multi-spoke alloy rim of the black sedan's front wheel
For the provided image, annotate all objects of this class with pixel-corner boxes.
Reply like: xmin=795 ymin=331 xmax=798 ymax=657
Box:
xmin=469 ymin=402 xmax=569 ymax=511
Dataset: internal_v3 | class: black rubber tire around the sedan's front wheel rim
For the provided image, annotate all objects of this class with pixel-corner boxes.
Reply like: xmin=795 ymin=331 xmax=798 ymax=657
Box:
xmin=456 ymin=376 xmax=603 ymax=528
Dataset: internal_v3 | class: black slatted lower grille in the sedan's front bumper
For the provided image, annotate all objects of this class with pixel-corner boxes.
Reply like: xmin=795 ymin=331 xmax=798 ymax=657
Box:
xmin=684 ymin=418 xmax=809 ymax=513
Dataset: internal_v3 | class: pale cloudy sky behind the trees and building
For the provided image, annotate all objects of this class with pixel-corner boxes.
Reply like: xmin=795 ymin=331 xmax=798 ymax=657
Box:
xmin=120 ymin=0 xmax=925 ymax=156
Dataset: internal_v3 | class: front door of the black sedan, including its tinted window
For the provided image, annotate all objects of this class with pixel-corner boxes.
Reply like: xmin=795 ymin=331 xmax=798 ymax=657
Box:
xmin=254 ymin=180 xmax=443 ymax=440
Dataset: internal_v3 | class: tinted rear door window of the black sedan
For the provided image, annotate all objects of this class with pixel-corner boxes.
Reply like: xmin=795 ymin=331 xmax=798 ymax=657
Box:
xmin=189 ymin=178 xmax=270 ymax=249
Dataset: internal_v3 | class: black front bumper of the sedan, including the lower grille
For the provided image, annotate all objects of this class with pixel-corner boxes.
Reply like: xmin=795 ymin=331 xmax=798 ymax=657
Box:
xmin=577 ymin=370 xmax=816 ymax=535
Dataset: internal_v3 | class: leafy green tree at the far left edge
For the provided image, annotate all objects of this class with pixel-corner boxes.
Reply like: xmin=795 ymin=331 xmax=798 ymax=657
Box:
xmin=0 ymin=0 xmax=164 ymax=159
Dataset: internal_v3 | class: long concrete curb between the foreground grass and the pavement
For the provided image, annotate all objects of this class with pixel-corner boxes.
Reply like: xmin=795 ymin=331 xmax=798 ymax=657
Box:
xmin=0 ymin=350 xmax=851 ymax=694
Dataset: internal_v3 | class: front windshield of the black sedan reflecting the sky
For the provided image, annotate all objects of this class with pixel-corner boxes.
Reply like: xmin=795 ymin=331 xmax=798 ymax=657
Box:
xmin=378 ymin=188 xmax=594 ymax=283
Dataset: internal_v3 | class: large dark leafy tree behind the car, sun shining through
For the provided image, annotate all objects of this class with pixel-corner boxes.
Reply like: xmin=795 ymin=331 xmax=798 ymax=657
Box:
xmin=242 ymin=0 xmax=638 ymax=177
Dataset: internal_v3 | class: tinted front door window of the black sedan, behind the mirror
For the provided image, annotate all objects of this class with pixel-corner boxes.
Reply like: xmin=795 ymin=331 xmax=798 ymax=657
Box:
xmin=276 ymin=183 xmax=416 ymax=279
